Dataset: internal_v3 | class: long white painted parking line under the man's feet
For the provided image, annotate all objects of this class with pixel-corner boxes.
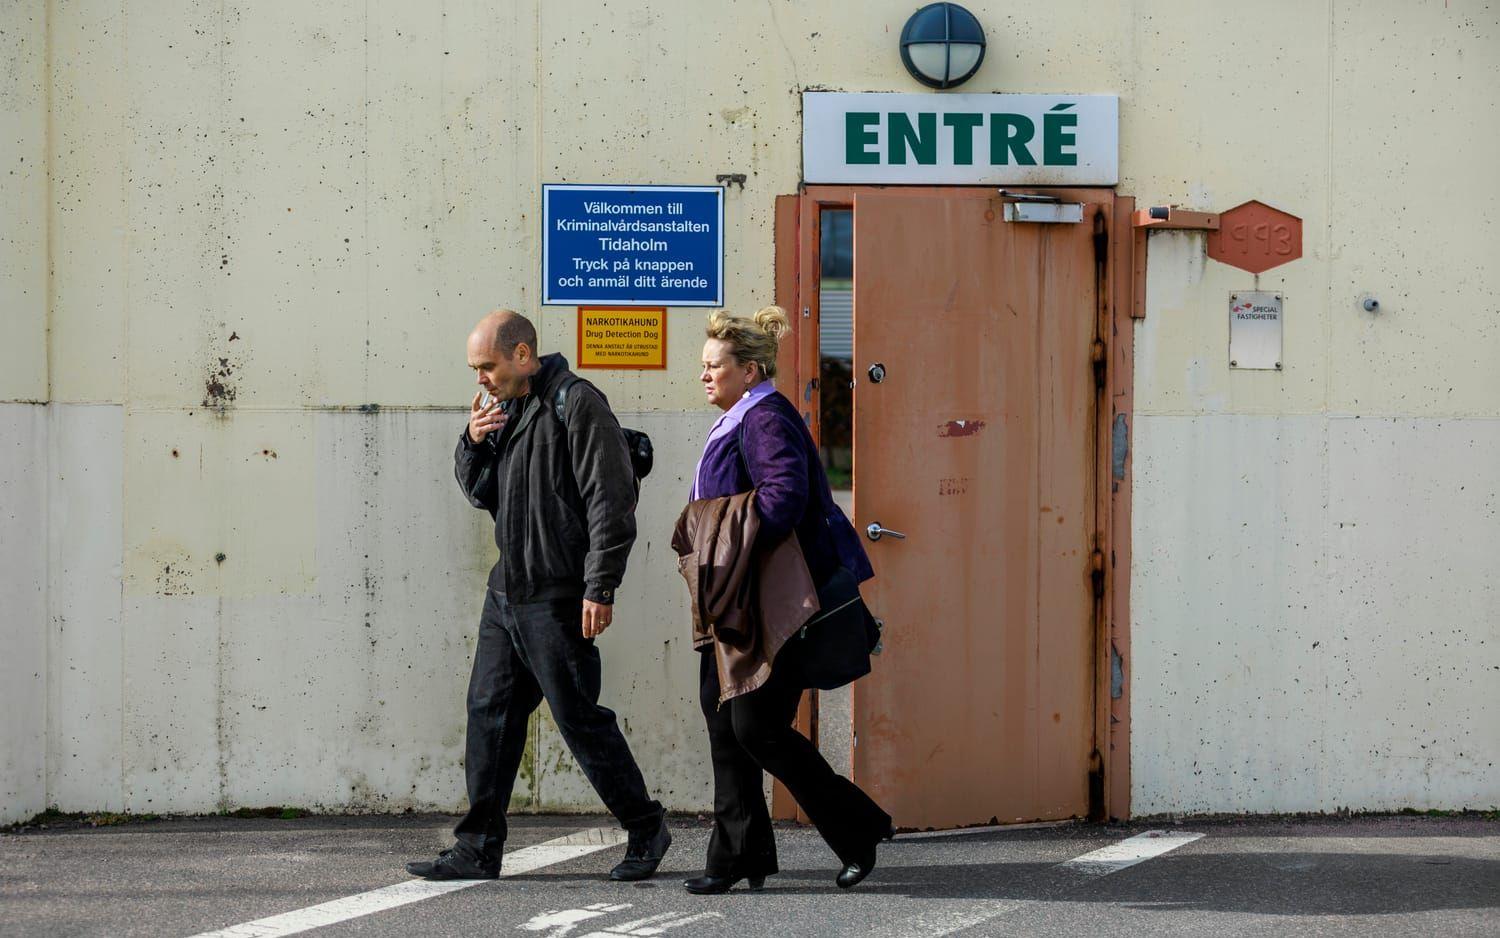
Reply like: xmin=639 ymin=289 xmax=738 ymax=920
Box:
xmin=192 ymin=827 xmax=626 ymax=938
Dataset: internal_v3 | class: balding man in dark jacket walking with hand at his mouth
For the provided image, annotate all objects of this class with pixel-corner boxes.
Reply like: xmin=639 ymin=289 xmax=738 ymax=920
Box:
xmin=407 ymin=309 xmax=672 ymax=881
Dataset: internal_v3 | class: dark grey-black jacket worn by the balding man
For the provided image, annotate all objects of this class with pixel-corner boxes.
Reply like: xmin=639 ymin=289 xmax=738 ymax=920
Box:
xmin=453 ymin=354 xmax=636 ymax=603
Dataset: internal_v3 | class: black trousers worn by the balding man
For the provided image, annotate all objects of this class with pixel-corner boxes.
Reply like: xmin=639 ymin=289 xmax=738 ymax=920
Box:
xmin=455 ymin=590 xmax=663 ymax=858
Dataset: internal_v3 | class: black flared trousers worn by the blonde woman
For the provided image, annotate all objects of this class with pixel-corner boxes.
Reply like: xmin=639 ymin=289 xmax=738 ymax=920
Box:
xmin=699 ymin=648 xmax=891 ymax=878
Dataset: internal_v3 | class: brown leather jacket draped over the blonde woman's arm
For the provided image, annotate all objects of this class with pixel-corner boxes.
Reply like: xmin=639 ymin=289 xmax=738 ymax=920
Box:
xmin=672 ymin=491 xmax=819 ymax=705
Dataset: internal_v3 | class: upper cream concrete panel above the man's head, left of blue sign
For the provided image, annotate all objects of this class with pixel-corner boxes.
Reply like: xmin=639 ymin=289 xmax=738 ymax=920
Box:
xmin=353 ymin=3 xmax=543 ymax=404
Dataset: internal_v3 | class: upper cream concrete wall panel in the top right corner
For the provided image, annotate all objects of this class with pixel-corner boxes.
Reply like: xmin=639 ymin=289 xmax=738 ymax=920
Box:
xmin=1325 ymin=3 xmax=1500 ymax=417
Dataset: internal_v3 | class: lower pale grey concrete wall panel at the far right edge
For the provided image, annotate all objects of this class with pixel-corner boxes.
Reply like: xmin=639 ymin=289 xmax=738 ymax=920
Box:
xmin=1319 ymin=417 xmax=1500 ymax=809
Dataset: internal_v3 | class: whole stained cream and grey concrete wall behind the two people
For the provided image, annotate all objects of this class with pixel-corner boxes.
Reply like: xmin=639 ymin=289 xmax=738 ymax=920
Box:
xmin=0 ymin=0 xmax=1500 ymax=818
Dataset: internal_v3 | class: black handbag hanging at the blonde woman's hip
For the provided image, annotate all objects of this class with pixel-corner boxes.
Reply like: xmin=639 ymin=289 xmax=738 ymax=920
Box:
xmin=777 ymin=567 xmax=881 ymax=690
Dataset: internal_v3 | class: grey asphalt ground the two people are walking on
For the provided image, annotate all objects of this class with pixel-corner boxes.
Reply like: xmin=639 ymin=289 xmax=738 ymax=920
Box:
xmin=0 ymin=815 xmax=1500 ymax=938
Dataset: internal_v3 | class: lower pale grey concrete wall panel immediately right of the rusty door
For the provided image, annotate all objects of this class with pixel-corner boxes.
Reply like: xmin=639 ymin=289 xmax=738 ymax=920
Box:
xmin=1130 ymin=414 xmax=1347 ymax=815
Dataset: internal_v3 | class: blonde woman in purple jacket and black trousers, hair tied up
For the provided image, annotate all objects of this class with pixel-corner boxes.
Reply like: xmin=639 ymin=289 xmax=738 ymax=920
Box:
xmin=684 ymin=306 xmax=893 ymax=894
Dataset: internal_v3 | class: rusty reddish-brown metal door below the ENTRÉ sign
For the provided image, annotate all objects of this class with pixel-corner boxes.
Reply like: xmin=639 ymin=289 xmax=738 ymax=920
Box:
xmin=852 ymin=189 xmax=1098 ymax=828
